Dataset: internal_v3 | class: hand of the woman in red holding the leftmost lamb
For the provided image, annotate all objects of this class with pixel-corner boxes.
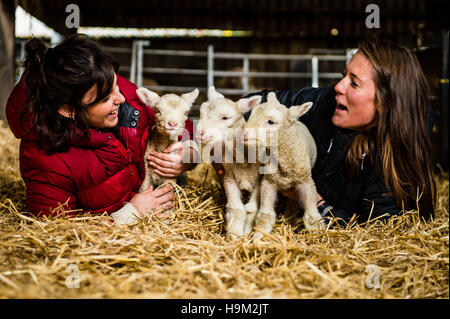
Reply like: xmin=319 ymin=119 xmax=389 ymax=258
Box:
xmin=147 ymin=142 xmax=195 ymax=178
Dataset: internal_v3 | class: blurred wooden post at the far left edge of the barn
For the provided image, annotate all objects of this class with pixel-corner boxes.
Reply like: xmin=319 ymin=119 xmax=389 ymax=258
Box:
xmin=0 ymin=0 xmax=17 ymax=120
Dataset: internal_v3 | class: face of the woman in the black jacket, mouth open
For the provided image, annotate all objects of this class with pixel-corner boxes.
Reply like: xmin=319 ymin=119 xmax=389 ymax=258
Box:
xmin=332 ymin=53 xmax=377 ymax=131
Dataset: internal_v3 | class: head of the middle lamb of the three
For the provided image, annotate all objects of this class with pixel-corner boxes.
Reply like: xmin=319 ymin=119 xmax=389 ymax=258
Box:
xmin=196 ymin=86 xmax=261 ymax=144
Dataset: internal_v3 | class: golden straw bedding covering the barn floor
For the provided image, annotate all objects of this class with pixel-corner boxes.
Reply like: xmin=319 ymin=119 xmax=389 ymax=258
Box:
xmin=0 ymin=123 xmax=449 ymax=298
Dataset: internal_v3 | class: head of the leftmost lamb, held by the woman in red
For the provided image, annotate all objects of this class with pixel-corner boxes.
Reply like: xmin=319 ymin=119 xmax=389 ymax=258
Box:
xmin=136 ymin=88 xmax=199 ymax=136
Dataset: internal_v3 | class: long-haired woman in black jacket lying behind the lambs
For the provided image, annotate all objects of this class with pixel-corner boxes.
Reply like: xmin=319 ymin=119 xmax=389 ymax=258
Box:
xmin=215 ymin=40 xmax=436 ymax=225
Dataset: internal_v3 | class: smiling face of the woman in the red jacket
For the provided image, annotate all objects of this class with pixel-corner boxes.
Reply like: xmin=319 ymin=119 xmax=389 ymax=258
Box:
xmin=82 ymin=75 xmax=125 ymax=128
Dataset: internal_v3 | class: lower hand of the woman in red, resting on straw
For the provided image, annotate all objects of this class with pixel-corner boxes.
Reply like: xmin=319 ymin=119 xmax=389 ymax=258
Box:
xmin=130 ymin=185 xmax=175 ymax=215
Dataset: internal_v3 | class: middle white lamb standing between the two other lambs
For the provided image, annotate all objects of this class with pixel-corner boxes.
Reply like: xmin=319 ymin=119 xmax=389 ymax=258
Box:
xmin=196 ymin=86 xmax=261 ymax=237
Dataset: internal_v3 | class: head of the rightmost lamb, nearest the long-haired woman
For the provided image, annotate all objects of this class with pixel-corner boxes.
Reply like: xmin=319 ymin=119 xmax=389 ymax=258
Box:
xmin=243 ymin=92 xmax=313 ymax=147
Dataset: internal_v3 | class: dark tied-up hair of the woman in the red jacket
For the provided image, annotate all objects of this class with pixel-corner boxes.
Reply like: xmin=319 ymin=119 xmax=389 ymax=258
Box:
xmin=21 ymin=34 xmax=118 ymax=154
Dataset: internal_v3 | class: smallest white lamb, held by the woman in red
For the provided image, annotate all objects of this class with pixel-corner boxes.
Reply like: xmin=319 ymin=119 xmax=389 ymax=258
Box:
xmin=136 ymin=88 xmax=198 ymax=191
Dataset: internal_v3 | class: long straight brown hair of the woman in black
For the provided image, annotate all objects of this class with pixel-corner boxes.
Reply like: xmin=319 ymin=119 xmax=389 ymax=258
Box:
xmin=346 ymin=40 xmax=436 ymax=218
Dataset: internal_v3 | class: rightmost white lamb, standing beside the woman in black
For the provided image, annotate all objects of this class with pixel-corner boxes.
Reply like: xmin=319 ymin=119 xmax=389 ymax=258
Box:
xmin=244 ymin=92 xmax=322 ymax=237
